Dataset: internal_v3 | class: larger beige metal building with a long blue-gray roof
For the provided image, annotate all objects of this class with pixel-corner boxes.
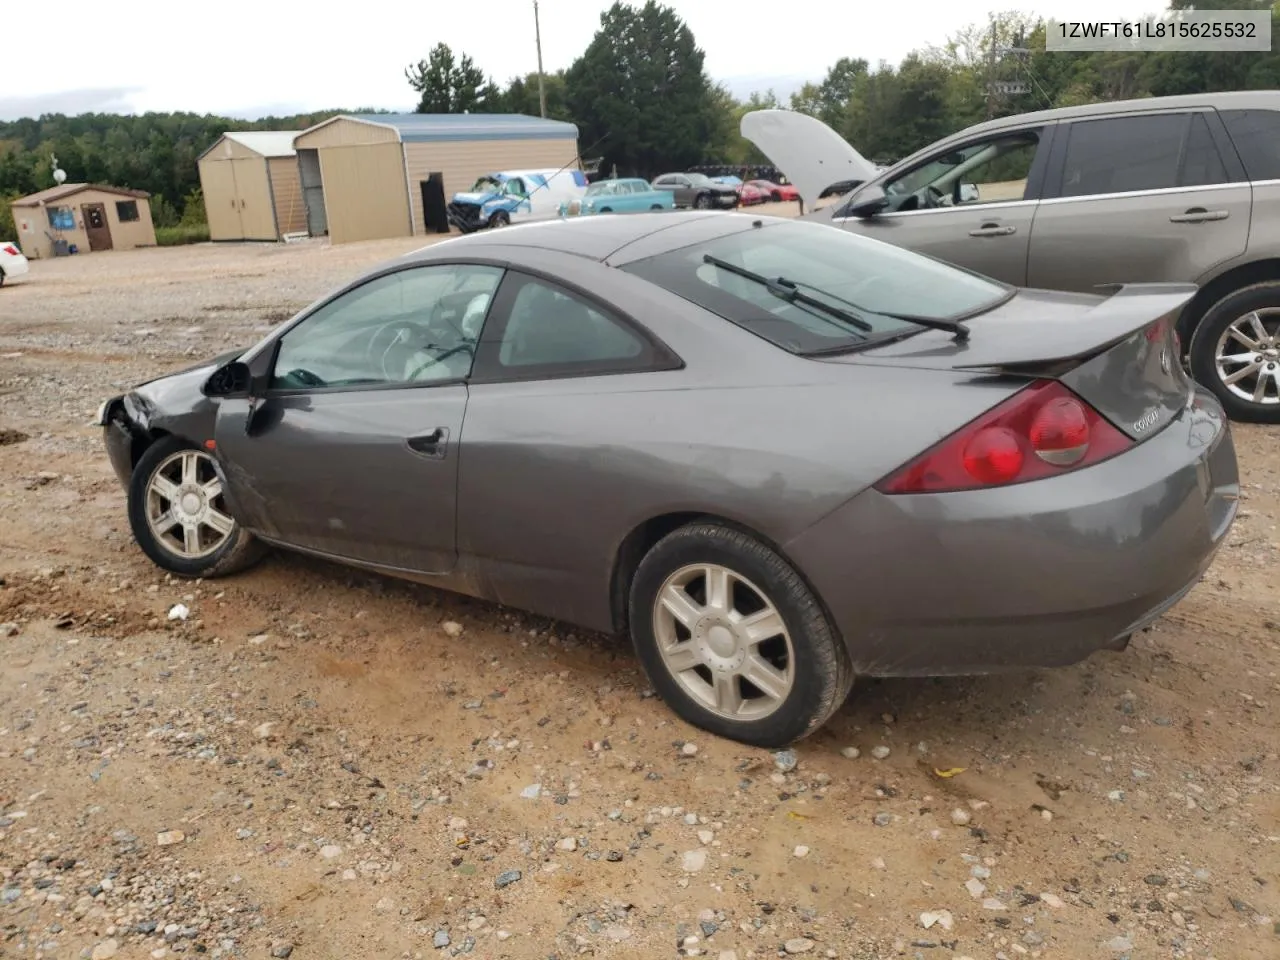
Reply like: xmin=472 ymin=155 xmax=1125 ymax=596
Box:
xmin=293 ymin=114 xmax=579 ymax=243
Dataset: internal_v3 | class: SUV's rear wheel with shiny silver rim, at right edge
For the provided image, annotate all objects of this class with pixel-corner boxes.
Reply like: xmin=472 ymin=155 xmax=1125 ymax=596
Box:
xmin=1188 ymin=283 xmax=1280 ymax=424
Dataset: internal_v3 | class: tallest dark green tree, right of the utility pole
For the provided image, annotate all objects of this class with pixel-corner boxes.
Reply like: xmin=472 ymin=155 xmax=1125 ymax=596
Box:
xmin=564 ymin=0 xmax=727 ymax=175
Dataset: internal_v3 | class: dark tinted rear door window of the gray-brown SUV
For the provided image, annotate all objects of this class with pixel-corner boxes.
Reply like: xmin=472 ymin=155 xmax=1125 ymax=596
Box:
xmin=1061 ymin=114 xmax=1228 ymax=197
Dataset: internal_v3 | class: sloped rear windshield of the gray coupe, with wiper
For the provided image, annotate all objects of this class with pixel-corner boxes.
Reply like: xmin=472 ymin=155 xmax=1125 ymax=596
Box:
xmin=621 ymin=223 xmax=1012 ymax=353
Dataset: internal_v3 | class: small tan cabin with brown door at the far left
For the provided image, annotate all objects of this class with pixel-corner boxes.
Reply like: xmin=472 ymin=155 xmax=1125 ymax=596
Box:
xmin=10 ymin=183 xmax=156 ymax=260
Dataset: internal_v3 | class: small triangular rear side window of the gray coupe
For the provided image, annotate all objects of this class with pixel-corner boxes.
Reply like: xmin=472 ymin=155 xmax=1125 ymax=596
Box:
xmin=495 ymin=274 xmax=654 ymax=375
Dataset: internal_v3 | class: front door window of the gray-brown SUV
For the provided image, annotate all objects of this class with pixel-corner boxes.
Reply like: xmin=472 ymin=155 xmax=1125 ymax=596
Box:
xmin=884 ymin=129 xmax=1041 ymax=211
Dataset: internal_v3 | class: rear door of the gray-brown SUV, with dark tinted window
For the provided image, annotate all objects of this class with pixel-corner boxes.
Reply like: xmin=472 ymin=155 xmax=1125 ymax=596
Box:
xmin=1027 ymin=109 xmax=1253 ymax=291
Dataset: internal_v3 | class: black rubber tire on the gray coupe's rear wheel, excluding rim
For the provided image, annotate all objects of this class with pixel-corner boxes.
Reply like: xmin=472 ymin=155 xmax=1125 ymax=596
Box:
xmin=628 ymin=521 xmax=854 ymax=748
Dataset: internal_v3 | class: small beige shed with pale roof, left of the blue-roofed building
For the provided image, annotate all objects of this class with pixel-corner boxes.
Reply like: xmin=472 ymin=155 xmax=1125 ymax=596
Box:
xmin=196 ymin=131 xmax=307 ymax=241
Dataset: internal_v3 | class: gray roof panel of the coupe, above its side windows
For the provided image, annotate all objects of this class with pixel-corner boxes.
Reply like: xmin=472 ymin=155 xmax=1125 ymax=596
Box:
xmin=408 ymin=210 xmax=762 ymax=262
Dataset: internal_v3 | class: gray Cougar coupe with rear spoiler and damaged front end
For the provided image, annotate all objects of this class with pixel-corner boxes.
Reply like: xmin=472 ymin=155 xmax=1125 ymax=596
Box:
xmin=99 ymin=212 xmax=1239 ymax=746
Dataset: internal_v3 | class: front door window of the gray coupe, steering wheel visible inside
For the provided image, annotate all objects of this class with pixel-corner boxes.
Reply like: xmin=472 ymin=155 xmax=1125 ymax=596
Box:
xmin=271 ymin=264 xmax=503 ymax=390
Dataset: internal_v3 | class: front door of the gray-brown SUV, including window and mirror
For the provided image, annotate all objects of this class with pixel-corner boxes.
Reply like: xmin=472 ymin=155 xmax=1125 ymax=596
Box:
xmin=835 ymin=124 xmax=1055 ymax=285
